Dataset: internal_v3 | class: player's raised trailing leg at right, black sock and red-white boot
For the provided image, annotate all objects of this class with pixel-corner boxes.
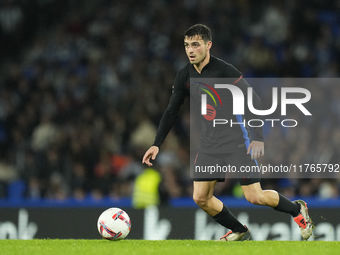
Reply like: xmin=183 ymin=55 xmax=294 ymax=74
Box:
xmin=241 ymin=182 xmax=313 ymax=240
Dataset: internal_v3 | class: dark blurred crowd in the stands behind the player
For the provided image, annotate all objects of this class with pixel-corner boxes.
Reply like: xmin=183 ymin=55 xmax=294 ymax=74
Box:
xmin=0 ymin=0 xmax=340 ymax=202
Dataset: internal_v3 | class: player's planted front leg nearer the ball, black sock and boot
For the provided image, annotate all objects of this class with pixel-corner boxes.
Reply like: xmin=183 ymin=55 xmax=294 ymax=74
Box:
xmin=193 ymin=180 xmax=249 ymax=241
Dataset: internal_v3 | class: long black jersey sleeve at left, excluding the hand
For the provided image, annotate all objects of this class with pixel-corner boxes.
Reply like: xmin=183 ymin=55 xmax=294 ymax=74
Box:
xmin=153 ymin=73 xmax=189 ymax=147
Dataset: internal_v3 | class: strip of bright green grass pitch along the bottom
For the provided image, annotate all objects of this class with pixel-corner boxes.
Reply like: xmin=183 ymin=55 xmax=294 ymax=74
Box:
xmin=0 ymin=239 xmax=340 ymax=255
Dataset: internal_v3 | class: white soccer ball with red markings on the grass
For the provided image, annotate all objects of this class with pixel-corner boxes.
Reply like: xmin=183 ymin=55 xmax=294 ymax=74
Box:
xmin=97 ymin=207 xmax=131 ymax=240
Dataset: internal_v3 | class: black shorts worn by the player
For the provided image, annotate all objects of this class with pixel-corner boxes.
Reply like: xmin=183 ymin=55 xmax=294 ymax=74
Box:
xmin=190 ymin=147 xmax=261 ymax=185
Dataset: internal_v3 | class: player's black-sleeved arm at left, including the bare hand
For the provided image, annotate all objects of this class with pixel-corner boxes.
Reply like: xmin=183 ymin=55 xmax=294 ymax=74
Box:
xmin=142 ymin=72 xmax=188 ymax=166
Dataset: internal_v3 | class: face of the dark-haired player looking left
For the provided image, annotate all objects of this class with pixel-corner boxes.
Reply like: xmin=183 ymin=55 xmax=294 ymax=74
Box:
xmin=184 ymin=36 xmax=212 ymax=65
